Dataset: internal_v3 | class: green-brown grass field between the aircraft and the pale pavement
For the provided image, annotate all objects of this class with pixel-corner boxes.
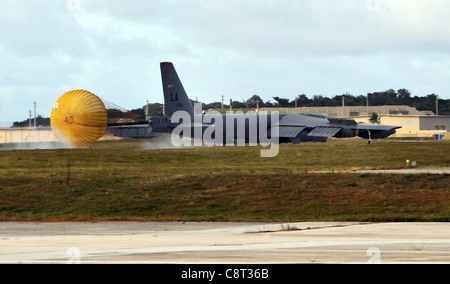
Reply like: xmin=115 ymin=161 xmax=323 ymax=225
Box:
xmin=0 ymin=139 xmax=450 ymax=221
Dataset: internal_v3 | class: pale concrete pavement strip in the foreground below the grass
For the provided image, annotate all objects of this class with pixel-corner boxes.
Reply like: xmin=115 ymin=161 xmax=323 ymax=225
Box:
xmin=0 ymin=222 xmax=450 ymax=264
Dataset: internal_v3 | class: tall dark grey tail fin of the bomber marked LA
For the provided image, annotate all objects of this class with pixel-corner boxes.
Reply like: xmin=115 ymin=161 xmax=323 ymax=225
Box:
xmin=161 ymin=62 xmax=194 ymax=117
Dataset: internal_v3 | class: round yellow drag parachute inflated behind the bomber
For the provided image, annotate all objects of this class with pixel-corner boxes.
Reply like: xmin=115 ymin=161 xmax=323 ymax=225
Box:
xmin=50 ymin=90 xmax=108 ymax=147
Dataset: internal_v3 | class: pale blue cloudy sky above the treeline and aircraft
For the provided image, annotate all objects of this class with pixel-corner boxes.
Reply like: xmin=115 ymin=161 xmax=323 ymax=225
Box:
xmin=0 ymin=0 xmax=450 ymax=124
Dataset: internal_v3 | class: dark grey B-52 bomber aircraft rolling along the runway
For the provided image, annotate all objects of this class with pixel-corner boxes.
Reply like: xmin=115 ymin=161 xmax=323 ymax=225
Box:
xmin=114 ymin=62 xmax=400 ymax=151
